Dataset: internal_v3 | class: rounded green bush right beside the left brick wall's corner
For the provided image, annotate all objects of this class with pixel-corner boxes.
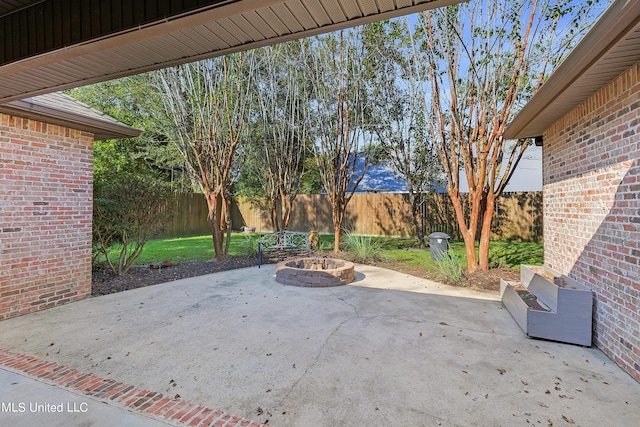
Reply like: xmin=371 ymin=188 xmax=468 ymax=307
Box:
xmin=93 ymin=171 xmax=174 ymax=276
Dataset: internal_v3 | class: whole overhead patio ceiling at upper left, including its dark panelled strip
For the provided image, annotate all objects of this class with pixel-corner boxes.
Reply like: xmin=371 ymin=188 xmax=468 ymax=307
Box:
xmin=0 ymin=0 xmax=461 ymax=102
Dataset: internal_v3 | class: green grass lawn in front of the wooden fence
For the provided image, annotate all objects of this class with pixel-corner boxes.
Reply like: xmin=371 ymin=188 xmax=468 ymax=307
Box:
xmin=122 ymin=233 xmax=542 ymax=270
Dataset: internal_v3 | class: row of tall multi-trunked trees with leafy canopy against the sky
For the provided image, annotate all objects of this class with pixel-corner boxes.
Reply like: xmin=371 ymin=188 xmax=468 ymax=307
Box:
xmin=70 ymin=0 xmax=607 ymax=264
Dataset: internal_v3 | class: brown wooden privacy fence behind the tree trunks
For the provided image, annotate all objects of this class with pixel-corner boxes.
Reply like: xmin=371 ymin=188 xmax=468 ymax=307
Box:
xmin=165 ymin=192 xmax=542 ymax=242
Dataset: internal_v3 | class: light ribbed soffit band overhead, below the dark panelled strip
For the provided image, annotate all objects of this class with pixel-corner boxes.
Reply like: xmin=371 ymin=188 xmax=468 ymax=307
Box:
xmin=0 ymin=0 xmax=460 ymax=102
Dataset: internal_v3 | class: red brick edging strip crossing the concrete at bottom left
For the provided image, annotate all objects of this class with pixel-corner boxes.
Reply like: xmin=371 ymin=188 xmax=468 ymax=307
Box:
xmin=0 ymin=348 xmax=264 ymax=427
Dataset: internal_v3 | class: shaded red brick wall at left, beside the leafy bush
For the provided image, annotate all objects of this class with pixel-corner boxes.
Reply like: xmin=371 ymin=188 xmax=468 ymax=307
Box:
xmin=0 ymin=114 xmax=93 ymax=319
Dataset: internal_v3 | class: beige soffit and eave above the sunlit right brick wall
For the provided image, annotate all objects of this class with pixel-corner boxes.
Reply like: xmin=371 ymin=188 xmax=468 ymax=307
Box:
xmin=504 ymin=0 xmax=640 ymax=139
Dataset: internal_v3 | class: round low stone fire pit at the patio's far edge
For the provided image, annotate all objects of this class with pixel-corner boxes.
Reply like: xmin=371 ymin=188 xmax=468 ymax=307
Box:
xmin=276 ymin=258 xmax=356 ymax=288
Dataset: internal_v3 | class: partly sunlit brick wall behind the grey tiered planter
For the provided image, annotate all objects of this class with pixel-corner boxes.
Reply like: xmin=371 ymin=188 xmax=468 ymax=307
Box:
xmin=543 ymin=63 xmax=640 ymax=380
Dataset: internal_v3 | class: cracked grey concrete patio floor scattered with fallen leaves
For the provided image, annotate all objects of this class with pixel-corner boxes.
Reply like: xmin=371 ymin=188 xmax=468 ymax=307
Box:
xmin=0 ymin=265 xmax=640 ymax=426
